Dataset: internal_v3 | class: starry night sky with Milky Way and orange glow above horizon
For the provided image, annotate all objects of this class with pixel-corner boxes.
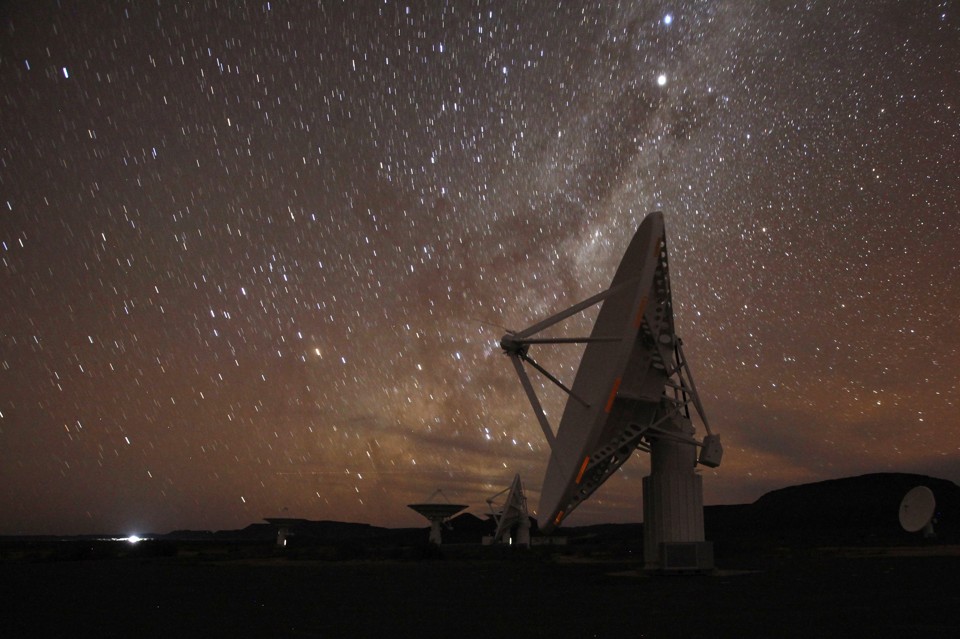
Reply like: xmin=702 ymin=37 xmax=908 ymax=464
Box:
xmin=0 ymin=0 xmax=960 ymax=534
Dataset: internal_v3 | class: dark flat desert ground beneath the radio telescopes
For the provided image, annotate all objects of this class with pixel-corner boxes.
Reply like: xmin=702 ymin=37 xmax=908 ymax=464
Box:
xmin=0 ymin=546 xmax=960 ymax=639
